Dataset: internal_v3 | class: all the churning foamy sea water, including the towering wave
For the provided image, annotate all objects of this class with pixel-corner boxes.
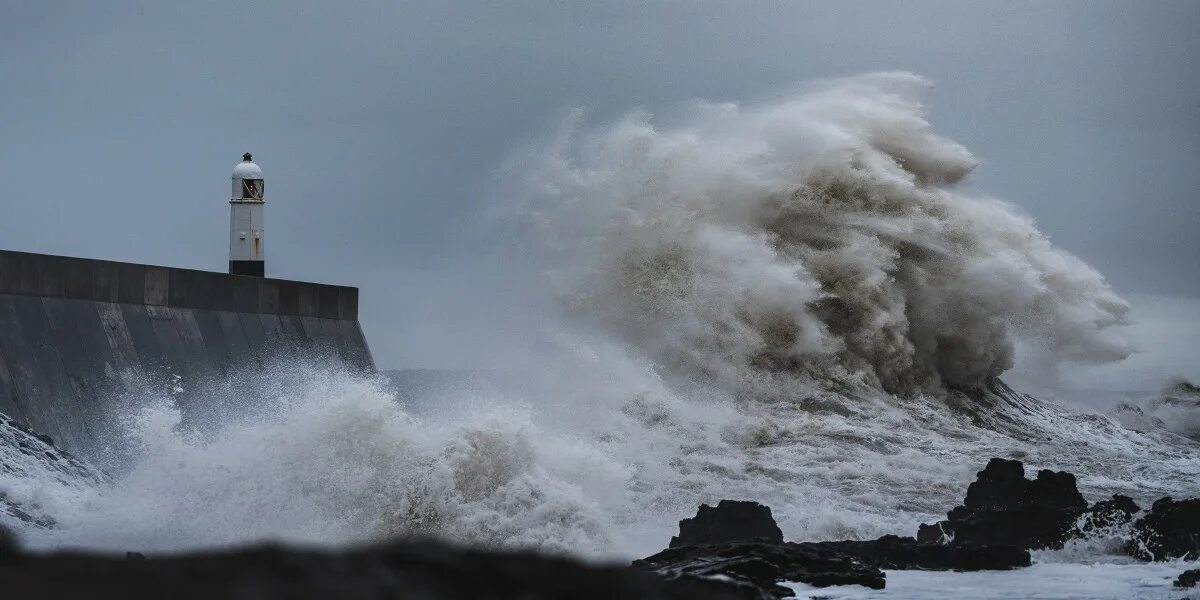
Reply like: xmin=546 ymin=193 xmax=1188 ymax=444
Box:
xmin=0 ymin=73 xmax=1200 ymax=598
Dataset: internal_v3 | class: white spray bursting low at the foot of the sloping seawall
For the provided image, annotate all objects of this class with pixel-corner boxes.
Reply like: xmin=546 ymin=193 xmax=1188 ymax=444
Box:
xmin=25 ymin=365 xmax=611 ymax=552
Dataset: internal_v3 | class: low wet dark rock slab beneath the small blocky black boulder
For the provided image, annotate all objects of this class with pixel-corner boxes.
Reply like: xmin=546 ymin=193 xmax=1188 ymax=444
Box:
xmin=634 ymin=541 xmax=884 ymax=598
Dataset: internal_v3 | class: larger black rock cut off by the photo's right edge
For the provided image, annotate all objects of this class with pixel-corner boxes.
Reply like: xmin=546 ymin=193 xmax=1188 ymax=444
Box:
xmin=1126 ymin=498 xmax=1200 ymax=560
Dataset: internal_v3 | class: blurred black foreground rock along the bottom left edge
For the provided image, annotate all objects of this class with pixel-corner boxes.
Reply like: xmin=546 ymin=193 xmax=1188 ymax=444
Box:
xmin=0 ymin=542 xmax=739 ymax=600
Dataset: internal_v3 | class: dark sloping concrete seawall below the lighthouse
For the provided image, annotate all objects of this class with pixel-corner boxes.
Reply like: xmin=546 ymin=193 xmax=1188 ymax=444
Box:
xmin=0 ymin=251 xmax=374 ymax=456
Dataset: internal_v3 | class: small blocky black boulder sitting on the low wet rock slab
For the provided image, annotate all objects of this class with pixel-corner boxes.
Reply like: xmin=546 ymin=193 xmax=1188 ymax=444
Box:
xmin=668 ymin=500 xmax=784 ymax=548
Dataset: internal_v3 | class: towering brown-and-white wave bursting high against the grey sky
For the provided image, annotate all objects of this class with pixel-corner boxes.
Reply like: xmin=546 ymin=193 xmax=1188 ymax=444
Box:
xmin=514 ymin=73 xmax=1130 ymax=395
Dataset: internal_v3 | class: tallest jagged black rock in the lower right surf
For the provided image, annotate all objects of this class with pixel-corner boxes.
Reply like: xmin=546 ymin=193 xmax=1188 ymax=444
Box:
xmin=917 ymin=458 xmax=1087 ymax=550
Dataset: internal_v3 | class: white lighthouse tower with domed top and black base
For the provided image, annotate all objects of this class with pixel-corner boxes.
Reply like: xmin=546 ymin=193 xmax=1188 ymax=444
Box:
xmin=229 ymin=152 xmax=266 ymax=277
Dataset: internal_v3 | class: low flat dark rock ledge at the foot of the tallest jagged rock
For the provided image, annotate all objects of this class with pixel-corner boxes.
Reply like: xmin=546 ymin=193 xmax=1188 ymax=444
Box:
xmin=798 ymin=535 xmax=1031 ymax=571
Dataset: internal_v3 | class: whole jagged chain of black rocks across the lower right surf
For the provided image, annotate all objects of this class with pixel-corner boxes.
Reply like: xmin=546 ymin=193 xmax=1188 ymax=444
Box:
xmin=634 ymin=458 xmax=1200 ymax=598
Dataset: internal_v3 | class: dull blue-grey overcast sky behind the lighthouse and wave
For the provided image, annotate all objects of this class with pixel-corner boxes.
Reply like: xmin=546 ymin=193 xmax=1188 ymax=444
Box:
xmin=0 ymin=0 xmax=1200 ymax=388
